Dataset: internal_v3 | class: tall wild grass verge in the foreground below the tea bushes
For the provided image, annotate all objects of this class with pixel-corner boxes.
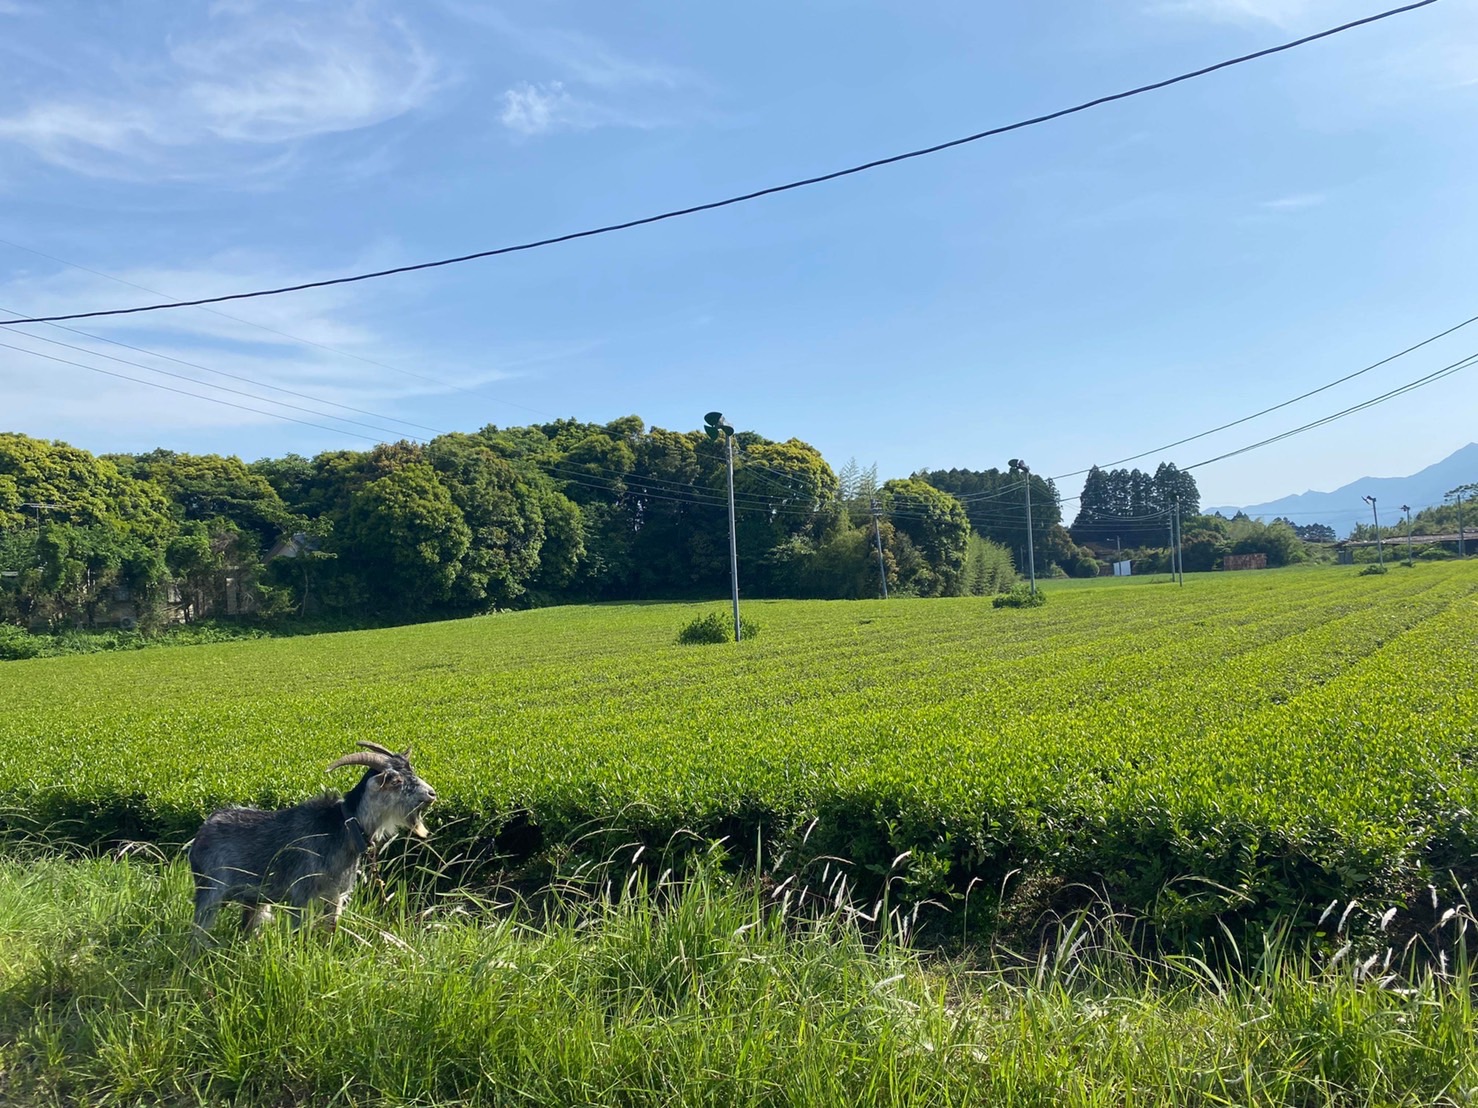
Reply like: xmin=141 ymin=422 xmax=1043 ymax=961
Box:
xmin=0 ymin=858 xmax=1478 ymax=1105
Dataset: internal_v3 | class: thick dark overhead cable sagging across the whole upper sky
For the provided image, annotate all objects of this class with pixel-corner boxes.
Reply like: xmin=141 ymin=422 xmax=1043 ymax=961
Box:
xmin=0 ymin=0 xmax=1437 ymax=326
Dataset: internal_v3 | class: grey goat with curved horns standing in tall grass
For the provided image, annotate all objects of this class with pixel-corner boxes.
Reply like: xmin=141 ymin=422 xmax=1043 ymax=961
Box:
xmin=189 ymin=742 xmax=436 ymax=934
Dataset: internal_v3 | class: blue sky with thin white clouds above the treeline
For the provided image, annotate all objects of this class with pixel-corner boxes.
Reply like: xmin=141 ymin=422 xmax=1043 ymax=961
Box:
xmin=0 ymin=0 xmax=1478 ymax=504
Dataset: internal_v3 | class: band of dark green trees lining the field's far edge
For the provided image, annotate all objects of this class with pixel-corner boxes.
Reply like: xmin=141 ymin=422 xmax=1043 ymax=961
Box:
xmin=0 ymin=415 xmax=1407 ymax=631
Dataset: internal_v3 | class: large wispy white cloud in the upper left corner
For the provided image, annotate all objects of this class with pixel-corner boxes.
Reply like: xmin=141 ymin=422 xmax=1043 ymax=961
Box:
xmin=0 ymin=0 xmax=437 ymax=179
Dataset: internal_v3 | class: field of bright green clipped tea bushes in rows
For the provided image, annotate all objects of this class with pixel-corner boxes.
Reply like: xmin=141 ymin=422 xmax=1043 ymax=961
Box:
xmin=0 ymin=563 xmax=1478 ymax=941
